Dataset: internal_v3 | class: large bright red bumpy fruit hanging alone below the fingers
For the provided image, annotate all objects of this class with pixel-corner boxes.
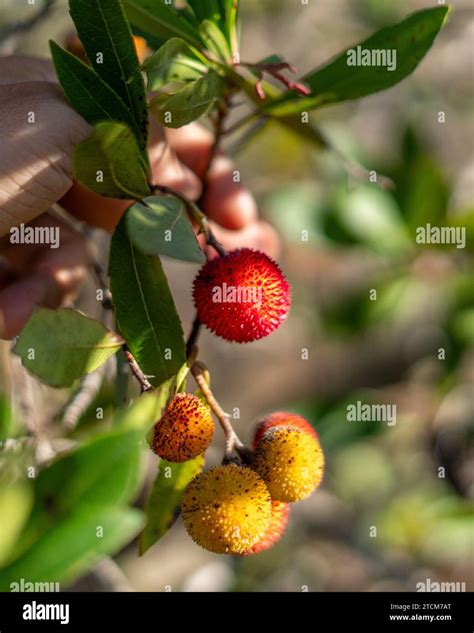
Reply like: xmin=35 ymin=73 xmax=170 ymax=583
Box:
xmin=193 ymin=248 xmax=291 ymax=343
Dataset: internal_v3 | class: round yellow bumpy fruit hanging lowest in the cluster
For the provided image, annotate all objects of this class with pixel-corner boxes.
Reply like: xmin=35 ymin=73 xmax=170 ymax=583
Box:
xmin=181 ymin=464 xmax=272 ymax=554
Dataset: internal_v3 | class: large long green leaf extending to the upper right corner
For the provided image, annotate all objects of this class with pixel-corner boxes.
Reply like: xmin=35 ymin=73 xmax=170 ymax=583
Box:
xmin=264 ymin=6 xmax=449 ymax=116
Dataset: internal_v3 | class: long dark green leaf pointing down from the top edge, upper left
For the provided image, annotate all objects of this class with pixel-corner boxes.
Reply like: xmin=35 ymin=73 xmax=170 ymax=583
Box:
xmin=69 ymin=0 xmax=148 ymax=150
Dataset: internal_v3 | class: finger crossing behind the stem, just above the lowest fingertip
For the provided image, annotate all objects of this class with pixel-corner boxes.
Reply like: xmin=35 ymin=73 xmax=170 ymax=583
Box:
xmin=166 ymin=123 xmax=258 ymax=230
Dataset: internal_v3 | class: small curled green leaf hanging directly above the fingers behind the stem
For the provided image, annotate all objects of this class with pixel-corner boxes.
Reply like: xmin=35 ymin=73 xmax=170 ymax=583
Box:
xmin=150 ymin=72 xmax=224 ymax=128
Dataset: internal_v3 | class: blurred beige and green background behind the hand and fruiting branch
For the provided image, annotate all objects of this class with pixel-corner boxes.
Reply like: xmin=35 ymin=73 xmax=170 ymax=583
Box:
xmin=0 ymin=0 xmax=474 ymax=592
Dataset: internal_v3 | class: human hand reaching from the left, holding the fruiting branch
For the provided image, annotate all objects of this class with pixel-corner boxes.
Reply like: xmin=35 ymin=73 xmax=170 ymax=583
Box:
xmin=0 ymin=57 xmax=278 ymax=339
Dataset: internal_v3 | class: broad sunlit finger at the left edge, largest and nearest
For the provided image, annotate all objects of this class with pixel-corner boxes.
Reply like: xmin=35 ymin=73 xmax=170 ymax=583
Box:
xmin=0 ymin=81 xmax=90 ymax=235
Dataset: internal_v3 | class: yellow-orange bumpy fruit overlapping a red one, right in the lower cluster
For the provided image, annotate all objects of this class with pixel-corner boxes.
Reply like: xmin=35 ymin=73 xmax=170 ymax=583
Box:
xmin=251 ymin=426 xmax=324 ymax=502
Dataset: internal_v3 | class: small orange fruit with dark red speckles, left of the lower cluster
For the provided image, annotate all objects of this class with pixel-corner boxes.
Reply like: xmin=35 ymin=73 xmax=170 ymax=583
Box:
xmin=152 ymin=393 xmax=214 ymax=462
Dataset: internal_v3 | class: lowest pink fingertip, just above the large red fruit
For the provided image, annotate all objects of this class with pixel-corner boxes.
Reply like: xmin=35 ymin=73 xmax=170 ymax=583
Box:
xmin=198 ymin=221 xmax=280 ymax=259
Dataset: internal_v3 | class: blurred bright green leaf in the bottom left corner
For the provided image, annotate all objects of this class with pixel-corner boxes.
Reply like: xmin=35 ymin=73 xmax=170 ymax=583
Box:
xmin=0 ymin=504 xmax=143 ymax=591
